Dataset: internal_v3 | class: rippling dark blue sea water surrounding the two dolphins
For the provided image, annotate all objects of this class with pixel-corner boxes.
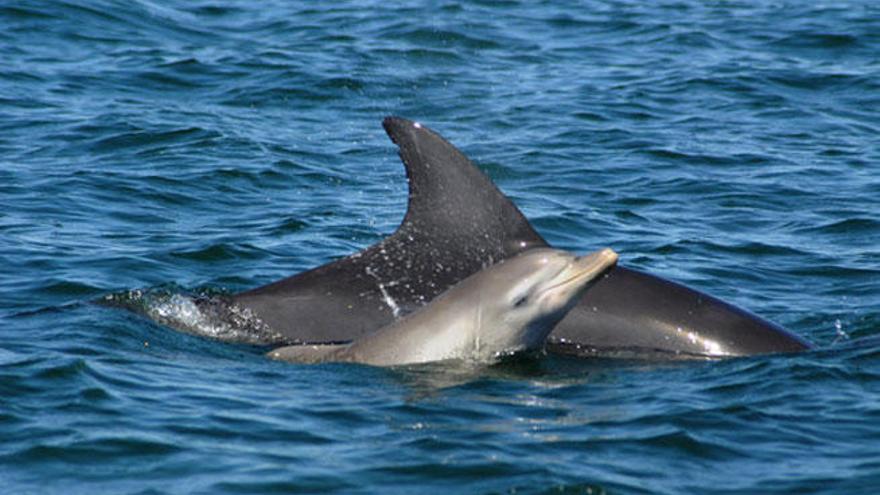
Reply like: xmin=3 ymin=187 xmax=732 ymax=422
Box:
xmin=0 ymin=0 xmax=880 ymax=495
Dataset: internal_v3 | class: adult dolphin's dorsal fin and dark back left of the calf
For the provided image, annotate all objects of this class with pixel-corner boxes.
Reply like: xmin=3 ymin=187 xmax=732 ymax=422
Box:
xmin=233 ymin=117 xmax=547 ymax=342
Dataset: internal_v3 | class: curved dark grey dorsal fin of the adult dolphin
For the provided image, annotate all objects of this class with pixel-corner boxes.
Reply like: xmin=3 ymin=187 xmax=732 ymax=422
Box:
xmin=382 ymin=117 xmax=546 ymax=256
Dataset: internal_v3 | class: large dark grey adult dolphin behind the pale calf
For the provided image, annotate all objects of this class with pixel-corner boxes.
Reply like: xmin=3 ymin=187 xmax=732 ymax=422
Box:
xmin=232 ymin=117 xmax=809 ymax=356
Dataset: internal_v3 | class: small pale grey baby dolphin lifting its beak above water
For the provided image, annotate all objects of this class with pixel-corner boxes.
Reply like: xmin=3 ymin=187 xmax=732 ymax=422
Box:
xmin=268 ymin=248 xmax=617 ymax=366
